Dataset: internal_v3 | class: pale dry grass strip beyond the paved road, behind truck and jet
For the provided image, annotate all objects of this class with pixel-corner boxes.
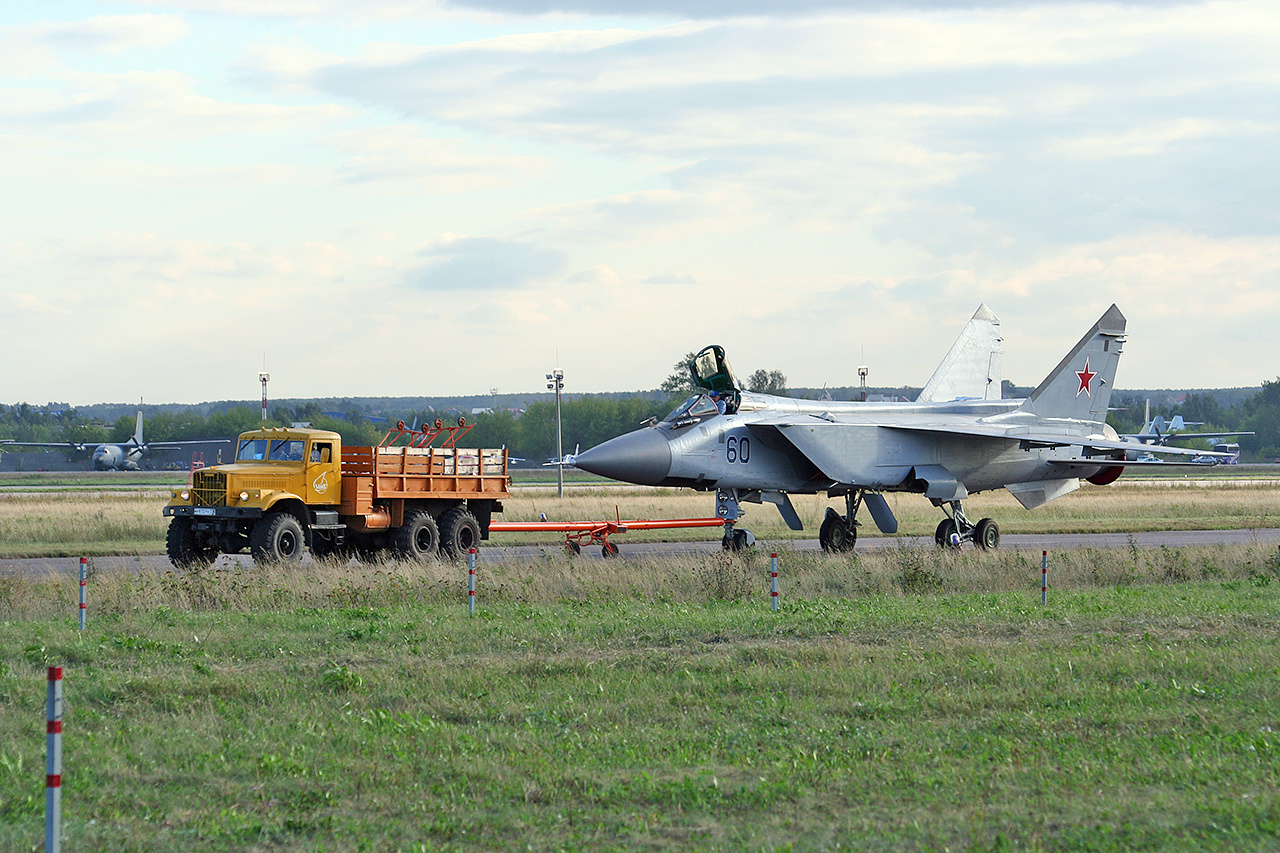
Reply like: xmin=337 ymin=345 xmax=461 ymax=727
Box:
xmin=0 ymin=480 xmax=1280 ymax=557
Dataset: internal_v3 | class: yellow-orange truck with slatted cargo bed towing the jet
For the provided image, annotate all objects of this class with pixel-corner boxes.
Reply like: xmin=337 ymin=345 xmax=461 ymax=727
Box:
xmin=164 ymin=419 xmax=511 ymax=569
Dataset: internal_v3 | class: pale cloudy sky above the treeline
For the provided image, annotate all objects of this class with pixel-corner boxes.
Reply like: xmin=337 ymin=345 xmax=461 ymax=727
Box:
xmin=0 ymin=0 xmax=1280 ymax=405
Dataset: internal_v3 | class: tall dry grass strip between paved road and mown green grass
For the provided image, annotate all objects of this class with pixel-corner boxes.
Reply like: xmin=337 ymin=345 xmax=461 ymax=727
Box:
xmin=0 ymin=544 xmax=1276 ymax=617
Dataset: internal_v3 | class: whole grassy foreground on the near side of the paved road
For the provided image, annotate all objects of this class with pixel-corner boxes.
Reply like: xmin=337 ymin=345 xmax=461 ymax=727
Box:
xmin=0 ymin=547 xmax=1280 ymax=850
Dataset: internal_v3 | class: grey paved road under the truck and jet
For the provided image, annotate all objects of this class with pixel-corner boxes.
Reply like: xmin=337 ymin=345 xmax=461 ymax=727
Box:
xmin=10 ymin=528 xmax=1280 ymax=576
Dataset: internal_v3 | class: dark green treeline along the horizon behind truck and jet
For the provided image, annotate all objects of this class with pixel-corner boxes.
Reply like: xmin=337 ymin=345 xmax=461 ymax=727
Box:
xmin=0 ymin=378 xmax=1280 ymax=464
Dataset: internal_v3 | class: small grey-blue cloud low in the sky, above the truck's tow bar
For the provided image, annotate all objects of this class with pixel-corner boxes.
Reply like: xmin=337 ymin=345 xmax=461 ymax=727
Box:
xmin=406 ymin=236 xmax=568 ymax=292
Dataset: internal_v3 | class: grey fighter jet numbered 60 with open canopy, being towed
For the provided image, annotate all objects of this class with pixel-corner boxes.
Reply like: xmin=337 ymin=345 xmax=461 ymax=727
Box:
xmin=575 ymin=305 xmax=1223 ymax=551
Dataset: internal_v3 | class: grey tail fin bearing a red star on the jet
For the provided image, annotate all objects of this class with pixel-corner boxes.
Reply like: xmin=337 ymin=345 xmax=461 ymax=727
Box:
xmin=1021 ymin=305 xmax=1125 ymax=423
